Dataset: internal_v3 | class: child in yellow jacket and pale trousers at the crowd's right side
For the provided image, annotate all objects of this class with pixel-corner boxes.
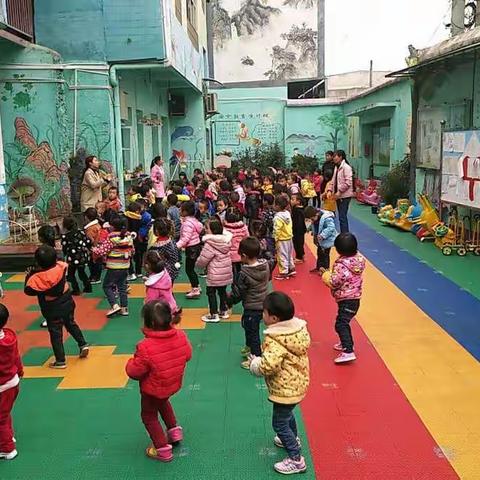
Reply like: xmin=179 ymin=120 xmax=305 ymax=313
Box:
xmin=273 ymin=196 xmax=296 ymax=280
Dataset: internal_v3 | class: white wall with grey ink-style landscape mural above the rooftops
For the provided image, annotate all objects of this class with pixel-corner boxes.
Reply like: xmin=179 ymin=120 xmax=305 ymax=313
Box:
xmin=212 ymin=0 xmax=318 ymax=82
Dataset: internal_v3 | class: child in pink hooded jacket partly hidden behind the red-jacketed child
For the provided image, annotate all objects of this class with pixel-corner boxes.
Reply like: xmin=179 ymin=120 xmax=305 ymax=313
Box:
xmin=145 ymin=250 xmax=182 ymax=321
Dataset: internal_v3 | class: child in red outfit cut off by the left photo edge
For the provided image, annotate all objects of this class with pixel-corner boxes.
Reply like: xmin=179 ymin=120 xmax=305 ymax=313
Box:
xmin=0 ymin=303 xmax=23 ymax=460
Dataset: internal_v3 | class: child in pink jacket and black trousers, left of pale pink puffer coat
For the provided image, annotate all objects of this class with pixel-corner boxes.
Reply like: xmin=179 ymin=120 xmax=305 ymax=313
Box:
xmin=177 ymin=201 xmax=203 ymax=299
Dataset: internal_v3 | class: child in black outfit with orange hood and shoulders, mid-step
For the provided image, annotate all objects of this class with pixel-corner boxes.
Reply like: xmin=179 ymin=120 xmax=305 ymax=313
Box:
xmin=24 ymin=245 xmax=89 ymax=369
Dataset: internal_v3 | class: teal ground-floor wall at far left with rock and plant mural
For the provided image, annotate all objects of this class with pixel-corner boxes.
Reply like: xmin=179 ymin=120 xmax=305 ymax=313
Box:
xmin=0 ymin=44 xmax=113 ymax=221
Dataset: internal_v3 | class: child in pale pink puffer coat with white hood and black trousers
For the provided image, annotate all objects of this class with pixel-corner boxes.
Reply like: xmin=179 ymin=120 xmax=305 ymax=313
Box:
xmin=196 ymin=217 xmax=233 ymax=323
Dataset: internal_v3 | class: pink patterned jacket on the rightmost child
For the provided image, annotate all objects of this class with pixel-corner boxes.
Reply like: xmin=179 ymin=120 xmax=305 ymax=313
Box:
xmin=323 ymin=253 xmax=365 ymax=302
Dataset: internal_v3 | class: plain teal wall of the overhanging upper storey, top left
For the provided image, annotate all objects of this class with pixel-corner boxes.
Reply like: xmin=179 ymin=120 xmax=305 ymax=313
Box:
xmin=35 ymin=0 xmax=165 ymax=62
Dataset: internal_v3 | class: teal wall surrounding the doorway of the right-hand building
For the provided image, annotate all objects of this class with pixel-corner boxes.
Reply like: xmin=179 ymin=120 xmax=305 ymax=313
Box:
xmin=344 ymin=80 xmax=412 ymax=179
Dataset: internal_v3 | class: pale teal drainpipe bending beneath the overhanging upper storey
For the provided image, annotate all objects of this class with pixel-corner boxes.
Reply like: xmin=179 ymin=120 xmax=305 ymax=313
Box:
xmin=109 ymin=60 xmax=171 ymax=200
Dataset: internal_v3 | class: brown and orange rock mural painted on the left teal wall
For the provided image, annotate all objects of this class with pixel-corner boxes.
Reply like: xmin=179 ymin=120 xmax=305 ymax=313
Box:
xmin=4 ymin=117 xmax=71 ymax=219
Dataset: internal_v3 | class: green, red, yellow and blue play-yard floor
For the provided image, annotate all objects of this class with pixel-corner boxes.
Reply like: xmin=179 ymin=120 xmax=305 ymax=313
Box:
xmin=0 ymin=203 xmax=480 ymax=480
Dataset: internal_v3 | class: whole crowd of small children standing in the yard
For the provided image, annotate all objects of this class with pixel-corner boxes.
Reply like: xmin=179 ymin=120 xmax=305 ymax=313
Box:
xmin=0 ymin=158 xmax=365 ymax=474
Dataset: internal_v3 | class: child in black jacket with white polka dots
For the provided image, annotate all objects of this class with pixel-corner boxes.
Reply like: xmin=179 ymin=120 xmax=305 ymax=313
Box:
xmin=62 ymin=217 xmax=92 ymax=295
